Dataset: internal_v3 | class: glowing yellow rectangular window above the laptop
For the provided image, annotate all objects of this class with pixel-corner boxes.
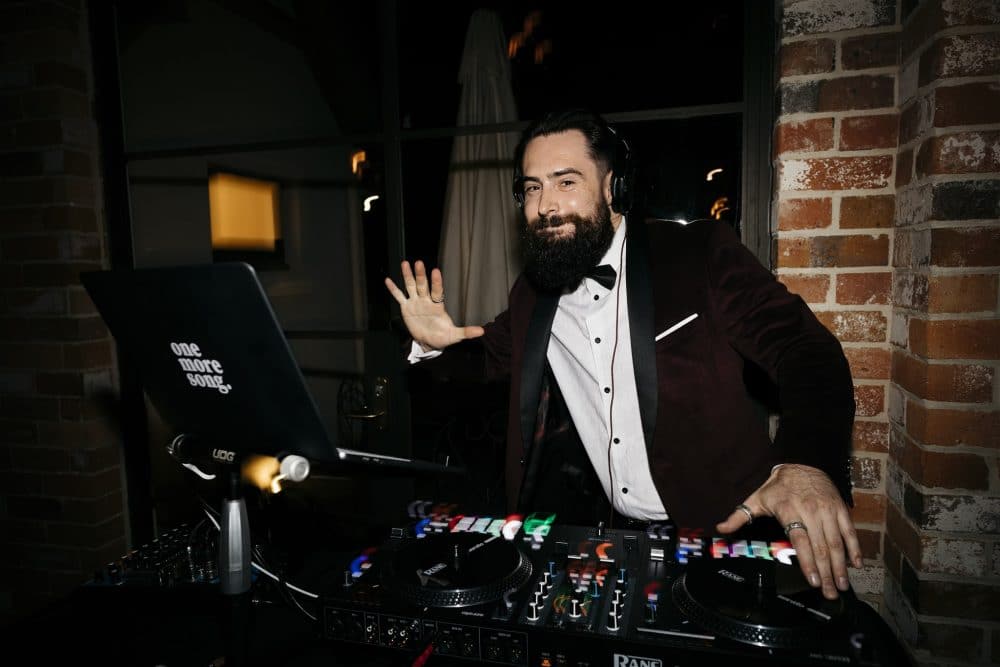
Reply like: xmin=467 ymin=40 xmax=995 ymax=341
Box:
xmin=208 ymin=173 xmax=281 ymax=251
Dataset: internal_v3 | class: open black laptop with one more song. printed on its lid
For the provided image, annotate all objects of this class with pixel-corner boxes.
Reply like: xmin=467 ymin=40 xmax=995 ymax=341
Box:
xmin=80 ymin=262 xmax=460 ymax=473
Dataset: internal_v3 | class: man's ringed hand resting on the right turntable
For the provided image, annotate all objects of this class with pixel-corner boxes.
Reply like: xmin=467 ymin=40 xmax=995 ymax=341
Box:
xmin=715 ymin=463 xmax=861 ymax=600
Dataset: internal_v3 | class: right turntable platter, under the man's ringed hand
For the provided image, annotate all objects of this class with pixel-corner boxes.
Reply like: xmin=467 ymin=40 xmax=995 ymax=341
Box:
xmin=672 ymin=558 xmax=847 ymax=649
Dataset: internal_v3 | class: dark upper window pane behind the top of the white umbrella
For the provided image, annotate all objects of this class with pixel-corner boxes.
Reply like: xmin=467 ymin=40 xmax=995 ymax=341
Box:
xmin=399 ymin=0 xmax=743 ymax=128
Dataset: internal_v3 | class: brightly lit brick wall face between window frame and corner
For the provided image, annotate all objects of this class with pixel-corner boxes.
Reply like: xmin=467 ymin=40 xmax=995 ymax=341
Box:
xmin=773 ymin=0 xmax=899 ymax=605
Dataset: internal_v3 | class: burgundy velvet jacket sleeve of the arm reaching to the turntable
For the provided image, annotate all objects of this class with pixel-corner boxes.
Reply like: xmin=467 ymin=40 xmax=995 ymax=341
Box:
xmin=709 ymin=225 xmax=855 ymax=503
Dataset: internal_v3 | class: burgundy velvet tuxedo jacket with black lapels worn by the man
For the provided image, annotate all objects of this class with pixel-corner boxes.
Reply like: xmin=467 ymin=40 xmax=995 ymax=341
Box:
xmin=472 ymin=221 xmax=854 ymax=528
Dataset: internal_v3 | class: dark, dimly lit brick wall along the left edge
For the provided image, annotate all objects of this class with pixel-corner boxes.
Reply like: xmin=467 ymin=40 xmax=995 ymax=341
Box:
xmin=0 ymin=1 xmax=125 ymax=622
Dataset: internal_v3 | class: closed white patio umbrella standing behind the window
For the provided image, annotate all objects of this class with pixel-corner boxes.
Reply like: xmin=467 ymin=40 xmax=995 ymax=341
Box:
xmin=439 ymin=9 xmax=521 ymax=325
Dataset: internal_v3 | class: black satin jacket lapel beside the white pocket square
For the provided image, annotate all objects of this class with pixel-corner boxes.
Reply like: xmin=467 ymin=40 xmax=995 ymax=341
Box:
xmin=624 ymin=219 xmax=659 ymax=449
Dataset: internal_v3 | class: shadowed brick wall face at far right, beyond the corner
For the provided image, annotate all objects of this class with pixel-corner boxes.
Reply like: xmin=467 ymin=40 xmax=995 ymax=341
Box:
xmin=885 ymin=0 xmax=1000 ymax=664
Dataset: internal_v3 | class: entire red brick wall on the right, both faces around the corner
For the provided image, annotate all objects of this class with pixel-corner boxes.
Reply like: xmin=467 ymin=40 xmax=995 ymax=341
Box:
xmin=774 ymin=0 xmax=1000 ymax=665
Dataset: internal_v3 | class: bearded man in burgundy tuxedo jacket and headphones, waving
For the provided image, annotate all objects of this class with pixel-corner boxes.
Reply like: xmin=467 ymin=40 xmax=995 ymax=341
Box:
xmin=386 ymin=111 xmax=861 ymax=599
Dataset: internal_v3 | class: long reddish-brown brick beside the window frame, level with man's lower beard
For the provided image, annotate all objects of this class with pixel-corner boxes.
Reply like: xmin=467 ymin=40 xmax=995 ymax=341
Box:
xmin=778 ymin=234 xmax=889 ymax=268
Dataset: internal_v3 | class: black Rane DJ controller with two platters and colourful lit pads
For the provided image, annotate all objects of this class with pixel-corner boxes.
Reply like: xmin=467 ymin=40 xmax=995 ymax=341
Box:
xmin=321 ymin=504 xmax=910 ymax=667
